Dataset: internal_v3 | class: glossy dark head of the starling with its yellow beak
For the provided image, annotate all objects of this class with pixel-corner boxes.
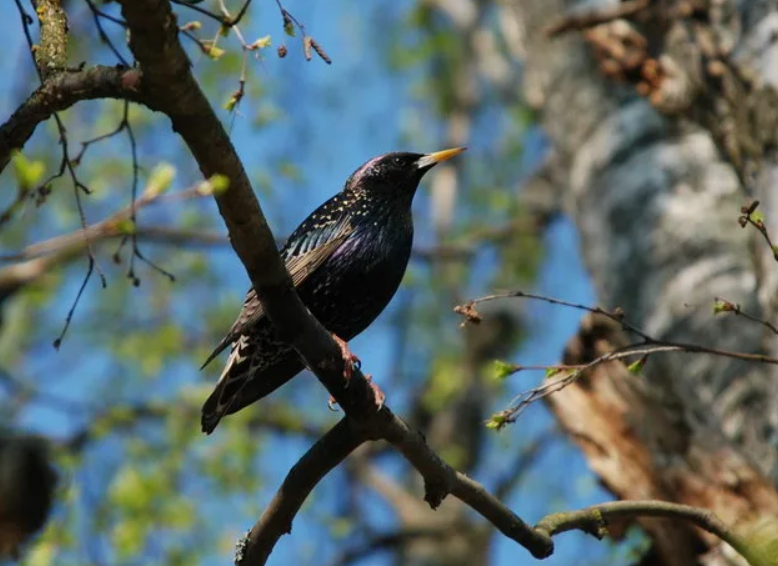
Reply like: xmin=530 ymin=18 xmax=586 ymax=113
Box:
xmin=346 ymin=147 xmax=466 ymax=201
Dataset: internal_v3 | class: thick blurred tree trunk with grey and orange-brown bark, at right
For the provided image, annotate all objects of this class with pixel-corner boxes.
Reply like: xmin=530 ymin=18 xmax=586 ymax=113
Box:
xmin=505 ymin=0 xmax=778 ymax=565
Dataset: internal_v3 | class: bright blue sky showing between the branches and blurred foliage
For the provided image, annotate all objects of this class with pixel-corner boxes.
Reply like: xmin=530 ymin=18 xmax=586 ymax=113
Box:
xmin=0 ymin=0 xmax=632 ymax=566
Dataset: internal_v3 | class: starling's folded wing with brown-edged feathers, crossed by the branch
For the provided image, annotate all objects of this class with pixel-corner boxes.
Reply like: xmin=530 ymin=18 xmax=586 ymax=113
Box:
xmin=200 ymin=221 xmax=354 ymax=369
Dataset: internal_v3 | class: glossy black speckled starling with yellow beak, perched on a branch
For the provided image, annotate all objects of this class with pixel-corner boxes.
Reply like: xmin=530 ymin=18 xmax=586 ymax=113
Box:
xmin=201 ymin=148 xmax=465 ymax=434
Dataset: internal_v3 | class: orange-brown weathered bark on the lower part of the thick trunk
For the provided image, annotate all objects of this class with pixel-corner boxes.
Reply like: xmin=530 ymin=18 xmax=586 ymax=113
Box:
xmin=548 ymin=316 xmax=778 ymax=566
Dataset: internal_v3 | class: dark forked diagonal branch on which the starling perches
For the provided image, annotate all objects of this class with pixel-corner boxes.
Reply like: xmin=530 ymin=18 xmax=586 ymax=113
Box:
xmin=112 ymin=0 xmax=552 ymax=564
